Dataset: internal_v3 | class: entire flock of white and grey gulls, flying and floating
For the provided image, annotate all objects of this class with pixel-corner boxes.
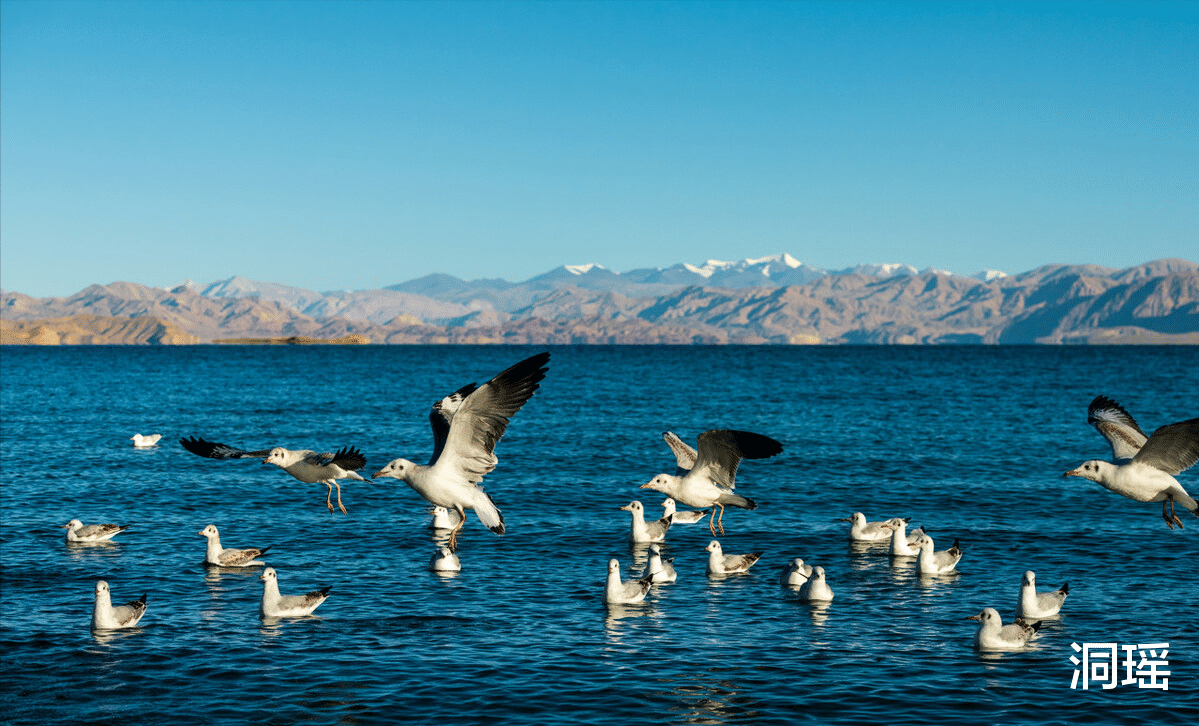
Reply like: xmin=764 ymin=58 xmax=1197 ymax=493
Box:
xmin=79 ymin=364 xmax=1199 ymax=651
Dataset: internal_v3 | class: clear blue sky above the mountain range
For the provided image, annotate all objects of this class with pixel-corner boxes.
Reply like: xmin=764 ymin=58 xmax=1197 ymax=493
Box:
xmin=0 ymin=0 xmax=1199 ymax=297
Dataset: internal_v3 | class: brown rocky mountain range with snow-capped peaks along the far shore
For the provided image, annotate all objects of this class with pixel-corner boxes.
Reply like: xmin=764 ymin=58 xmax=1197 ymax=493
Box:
xmin=0 ymin=254 xmax=1199 ymax=344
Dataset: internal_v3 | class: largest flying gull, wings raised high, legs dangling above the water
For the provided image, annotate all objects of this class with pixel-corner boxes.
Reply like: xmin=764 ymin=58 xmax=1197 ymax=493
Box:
xmin=373 ymin=352 xmax=549 ymax=550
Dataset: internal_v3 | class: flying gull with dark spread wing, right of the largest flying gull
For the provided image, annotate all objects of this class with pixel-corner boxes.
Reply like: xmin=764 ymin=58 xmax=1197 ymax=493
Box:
xmin=641 ymin=429 xmax=783 ymax=536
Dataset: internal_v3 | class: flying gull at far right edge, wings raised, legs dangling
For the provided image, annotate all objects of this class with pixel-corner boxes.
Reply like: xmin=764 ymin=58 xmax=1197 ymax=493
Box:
xmin=1062 ymin=395 xmax=1199 ymax=530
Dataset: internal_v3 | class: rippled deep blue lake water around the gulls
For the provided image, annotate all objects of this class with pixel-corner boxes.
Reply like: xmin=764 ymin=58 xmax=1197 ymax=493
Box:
xmin=0 ymin=346 xmax=1199 ymax=724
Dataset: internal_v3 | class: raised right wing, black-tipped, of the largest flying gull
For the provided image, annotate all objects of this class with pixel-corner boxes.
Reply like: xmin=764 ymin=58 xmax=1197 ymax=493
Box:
xmin=430 ymin=352 xmax=549 ymax=484
